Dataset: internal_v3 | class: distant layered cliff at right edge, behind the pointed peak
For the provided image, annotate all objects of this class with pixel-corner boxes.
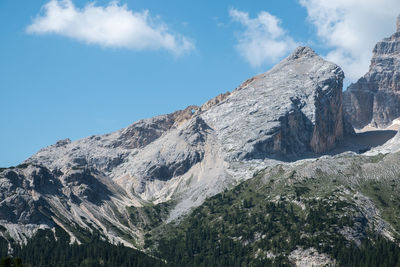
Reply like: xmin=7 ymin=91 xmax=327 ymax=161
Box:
xmin=343 ymin=17 xmax=400 ymax=128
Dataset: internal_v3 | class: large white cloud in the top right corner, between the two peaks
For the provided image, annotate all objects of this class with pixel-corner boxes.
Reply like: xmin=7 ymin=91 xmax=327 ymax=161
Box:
xmin=299 ymin=0 xmax=400 ymax=81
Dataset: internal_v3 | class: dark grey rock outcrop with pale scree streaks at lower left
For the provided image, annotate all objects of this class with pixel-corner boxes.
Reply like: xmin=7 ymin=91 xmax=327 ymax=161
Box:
xmin=0 ymin=164 xmax=140 ymax=245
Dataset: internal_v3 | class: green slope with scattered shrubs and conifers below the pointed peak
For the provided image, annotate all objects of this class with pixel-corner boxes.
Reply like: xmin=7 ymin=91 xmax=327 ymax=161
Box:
xmin=146 ymin=157 xmax=400 ymax=266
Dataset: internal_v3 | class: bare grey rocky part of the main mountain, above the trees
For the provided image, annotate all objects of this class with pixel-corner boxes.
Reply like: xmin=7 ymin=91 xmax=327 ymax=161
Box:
xmin=0 ymin=47 xmax=351 ymax=251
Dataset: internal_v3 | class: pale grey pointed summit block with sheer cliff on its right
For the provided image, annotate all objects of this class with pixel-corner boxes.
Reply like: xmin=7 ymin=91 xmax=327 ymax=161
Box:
xmin=201 ymin=47 xmax=344 ymax=160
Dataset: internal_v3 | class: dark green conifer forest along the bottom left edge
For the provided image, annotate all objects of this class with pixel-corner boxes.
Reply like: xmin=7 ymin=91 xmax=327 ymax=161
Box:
xmin=0 ymin=228 xmax=165 ymax=267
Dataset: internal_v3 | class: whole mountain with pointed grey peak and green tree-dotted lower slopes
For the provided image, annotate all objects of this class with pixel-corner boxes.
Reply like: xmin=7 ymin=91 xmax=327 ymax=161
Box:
xmin=0 ymin=42 xmax=400 ymax=266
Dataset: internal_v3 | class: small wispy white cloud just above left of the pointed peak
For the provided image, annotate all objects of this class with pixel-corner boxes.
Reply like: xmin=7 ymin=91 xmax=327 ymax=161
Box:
xmin=229 ymin=9 xmax=297 ymax=67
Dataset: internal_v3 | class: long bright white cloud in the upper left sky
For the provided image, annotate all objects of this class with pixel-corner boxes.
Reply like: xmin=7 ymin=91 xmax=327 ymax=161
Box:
xmin=26 ymin=0 xmax=194 ymax=54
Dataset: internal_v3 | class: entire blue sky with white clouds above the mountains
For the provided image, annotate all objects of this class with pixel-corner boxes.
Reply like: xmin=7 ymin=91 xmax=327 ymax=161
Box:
xmin=0 ymin=0 xmax=400 ymax=166
